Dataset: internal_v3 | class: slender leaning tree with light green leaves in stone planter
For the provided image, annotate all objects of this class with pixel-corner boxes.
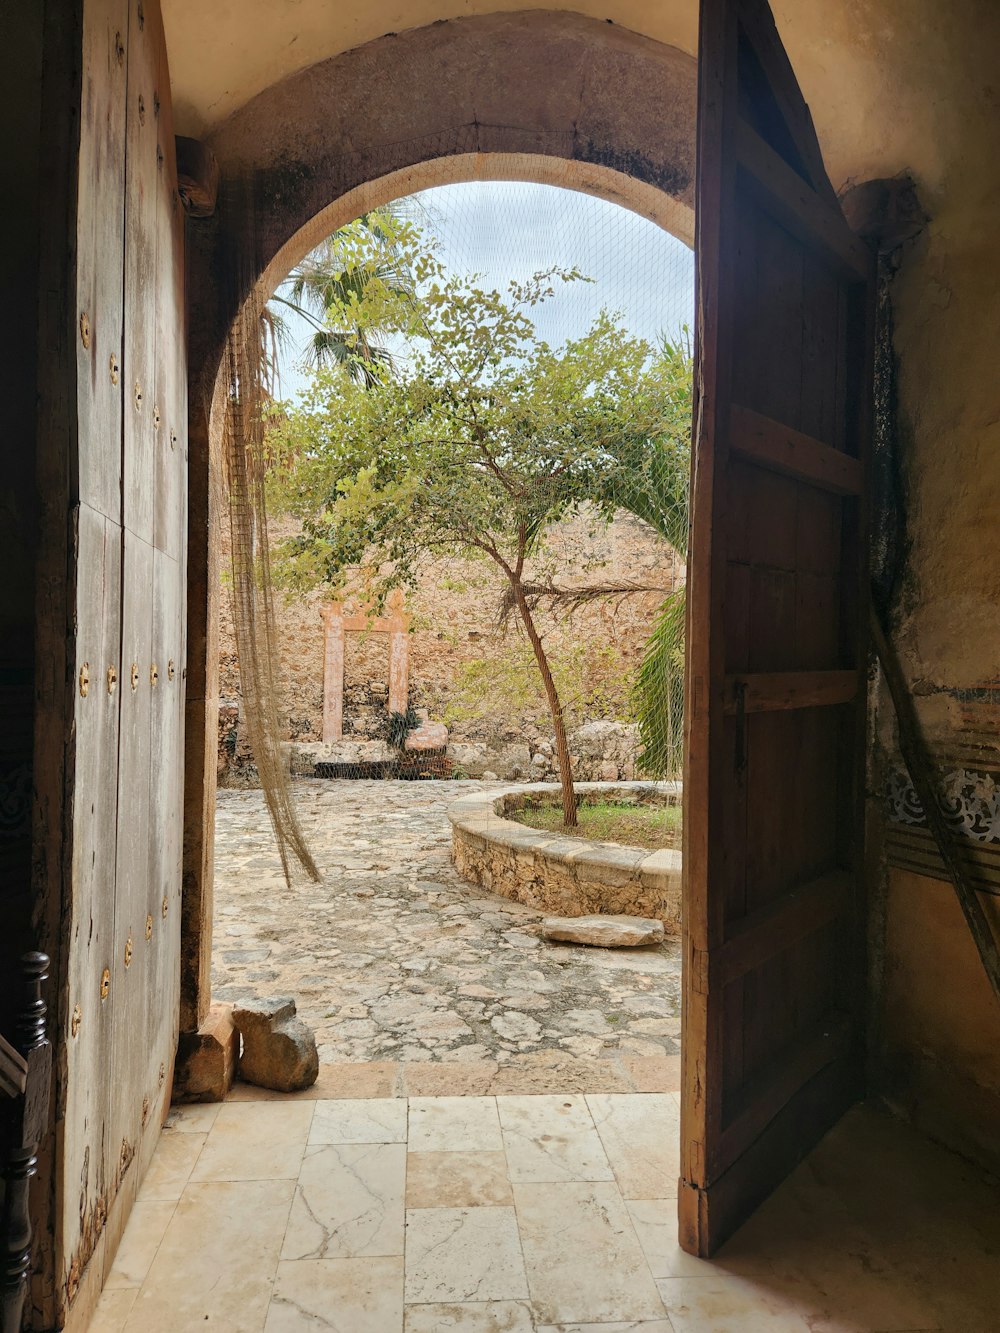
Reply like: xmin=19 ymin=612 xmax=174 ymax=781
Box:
xmin=273 ymin=264 xmax=688 ymax=826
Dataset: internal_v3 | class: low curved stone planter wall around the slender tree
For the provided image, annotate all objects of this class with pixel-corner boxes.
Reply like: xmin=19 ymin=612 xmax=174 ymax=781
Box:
xmin=448 ymin=782 xmax=681 ymax=934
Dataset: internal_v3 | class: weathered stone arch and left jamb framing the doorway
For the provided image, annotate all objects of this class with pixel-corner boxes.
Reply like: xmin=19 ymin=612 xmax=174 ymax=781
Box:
xmin=180 ymin=11 xmax=696 ymax=1061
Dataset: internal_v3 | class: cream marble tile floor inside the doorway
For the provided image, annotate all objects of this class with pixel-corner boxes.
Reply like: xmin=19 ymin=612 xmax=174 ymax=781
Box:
xmin=91 ymin=1093 xmax=1000 ymax=1333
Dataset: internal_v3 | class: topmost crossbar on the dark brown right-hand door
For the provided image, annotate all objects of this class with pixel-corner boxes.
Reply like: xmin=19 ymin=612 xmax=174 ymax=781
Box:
xmin=736 ymin=120 xmax=873 ymax=283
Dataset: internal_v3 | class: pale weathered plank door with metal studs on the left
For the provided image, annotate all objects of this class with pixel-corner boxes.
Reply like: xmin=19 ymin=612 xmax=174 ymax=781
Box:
xmin=48 ymin=0 xmax=187 ymax=1311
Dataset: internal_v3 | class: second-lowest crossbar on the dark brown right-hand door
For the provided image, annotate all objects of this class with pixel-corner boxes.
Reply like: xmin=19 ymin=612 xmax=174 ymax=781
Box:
xmin=709 ymin=870 xmax=853 ymax=986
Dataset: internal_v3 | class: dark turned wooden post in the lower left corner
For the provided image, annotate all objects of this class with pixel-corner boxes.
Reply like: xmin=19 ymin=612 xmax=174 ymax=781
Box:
xmin=0 ymin=953 xmax=52 ymax=1333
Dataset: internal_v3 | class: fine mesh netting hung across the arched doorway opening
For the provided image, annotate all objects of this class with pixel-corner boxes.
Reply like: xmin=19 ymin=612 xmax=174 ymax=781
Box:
xmin=221 ymin=163 xmax=693 ymax=858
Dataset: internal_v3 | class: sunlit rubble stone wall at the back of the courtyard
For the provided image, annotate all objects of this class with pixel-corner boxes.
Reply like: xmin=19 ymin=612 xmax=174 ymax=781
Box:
xmin=219 ymin=512 xmax=684 ymax=786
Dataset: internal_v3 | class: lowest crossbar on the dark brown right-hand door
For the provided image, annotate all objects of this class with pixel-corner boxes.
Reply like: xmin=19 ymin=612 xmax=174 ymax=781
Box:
xmin=716 ymin=1013 xmax=853 ymax=1170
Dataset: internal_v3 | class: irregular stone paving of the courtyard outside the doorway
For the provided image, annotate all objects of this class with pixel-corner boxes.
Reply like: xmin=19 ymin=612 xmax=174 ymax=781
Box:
xmin=213 ymin=780 xmax=680 ymax=1088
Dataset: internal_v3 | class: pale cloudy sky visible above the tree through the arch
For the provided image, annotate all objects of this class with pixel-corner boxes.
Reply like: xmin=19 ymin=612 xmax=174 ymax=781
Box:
xmin=274 ymin=181 xmax=695 ymax=399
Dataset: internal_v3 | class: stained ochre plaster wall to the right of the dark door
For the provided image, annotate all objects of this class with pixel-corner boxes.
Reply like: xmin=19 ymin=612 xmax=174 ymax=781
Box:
xmin=859 ymin=4 xmax=1000 ymax=1164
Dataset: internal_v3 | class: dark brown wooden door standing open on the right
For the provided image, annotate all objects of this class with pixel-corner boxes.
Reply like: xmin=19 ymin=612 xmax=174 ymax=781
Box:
xmin=679 ymin=0 xmax=873 ymax=1256
